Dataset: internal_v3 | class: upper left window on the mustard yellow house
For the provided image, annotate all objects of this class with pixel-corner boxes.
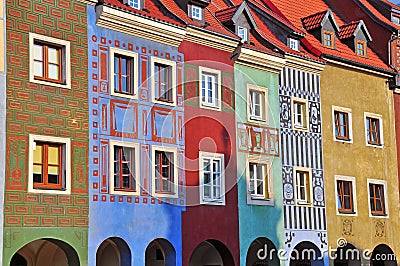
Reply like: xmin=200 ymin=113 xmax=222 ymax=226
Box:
xmin=332 ymin=106 xmax=353 ymax=142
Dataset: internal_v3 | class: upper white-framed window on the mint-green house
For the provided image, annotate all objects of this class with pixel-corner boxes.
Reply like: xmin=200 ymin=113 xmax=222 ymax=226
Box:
xmin=247 ymin=85 xmax=268 ymax=121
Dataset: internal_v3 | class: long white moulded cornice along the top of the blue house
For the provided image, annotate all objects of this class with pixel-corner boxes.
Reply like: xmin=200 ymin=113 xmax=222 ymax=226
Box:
xmin=96 ymin=6 xmax=185 ymax=47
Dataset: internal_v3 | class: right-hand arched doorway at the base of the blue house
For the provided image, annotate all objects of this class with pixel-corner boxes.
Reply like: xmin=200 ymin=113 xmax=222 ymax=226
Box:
xmin=145 ymin=238 xmax=176 ymax=266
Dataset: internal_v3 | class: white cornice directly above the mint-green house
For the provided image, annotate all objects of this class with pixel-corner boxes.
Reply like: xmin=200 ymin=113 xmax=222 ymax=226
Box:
xmin=236 ymin=47 xmax=285 ymax=74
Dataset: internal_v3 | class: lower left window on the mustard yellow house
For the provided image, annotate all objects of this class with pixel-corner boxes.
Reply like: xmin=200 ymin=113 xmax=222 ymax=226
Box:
xmin=335 ymin=176 xmax=357 ymax=215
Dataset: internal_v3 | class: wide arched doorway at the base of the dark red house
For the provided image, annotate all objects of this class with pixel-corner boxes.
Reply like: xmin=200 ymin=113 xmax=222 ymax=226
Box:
xmin=189 ymin=239 xmax=235 ymax=266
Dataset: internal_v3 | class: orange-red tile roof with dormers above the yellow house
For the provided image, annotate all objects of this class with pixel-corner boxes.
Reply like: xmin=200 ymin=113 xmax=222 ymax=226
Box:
xmin=263 ymin=0 xmax=392 ymax=71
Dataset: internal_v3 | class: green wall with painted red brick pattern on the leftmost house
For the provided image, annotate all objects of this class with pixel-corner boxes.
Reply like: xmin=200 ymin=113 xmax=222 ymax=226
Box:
xmin=4 ymin=0 xmax=88 ymax=227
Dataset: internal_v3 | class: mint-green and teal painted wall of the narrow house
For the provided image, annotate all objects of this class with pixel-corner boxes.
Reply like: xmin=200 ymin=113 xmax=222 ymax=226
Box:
xmin=235 ymin=64 xmax=284 ymax=265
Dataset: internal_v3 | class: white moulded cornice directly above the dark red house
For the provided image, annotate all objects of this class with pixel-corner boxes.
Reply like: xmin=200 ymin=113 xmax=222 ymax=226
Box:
xmin=185 ymin=26 xmax=239 ymax=52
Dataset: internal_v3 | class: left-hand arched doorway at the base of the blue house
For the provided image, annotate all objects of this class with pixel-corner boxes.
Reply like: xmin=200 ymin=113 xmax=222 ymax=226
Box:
xmin=96 ymin=237 xmax=132 ymax=266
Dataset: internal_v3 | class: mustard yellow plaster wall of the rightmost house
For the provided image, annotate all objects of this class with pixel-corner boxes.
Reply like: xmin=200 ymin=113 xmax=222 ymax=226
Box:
xmin=321 ymin=65 xmax=400 ymax=262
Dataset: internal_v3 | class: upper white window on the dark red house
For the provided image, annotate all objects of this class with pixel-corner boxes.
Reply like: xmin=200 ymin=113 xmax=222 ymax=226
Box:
xmin=199 ymin=67 xmax=221 ymax=110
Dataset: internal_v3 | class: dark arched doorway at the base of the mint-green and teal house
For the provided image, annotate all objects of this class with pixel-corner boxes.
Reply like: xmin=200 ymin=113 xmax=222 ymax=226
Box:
xmin=246 ymin=237 xmax=280 ymax=266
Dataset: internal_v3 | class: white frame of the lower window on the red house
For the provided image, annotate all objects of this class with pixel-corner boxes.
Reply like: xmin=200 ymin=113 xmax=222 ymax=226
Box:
xmin=199 ymin=151 xmax=225 ymax=205
